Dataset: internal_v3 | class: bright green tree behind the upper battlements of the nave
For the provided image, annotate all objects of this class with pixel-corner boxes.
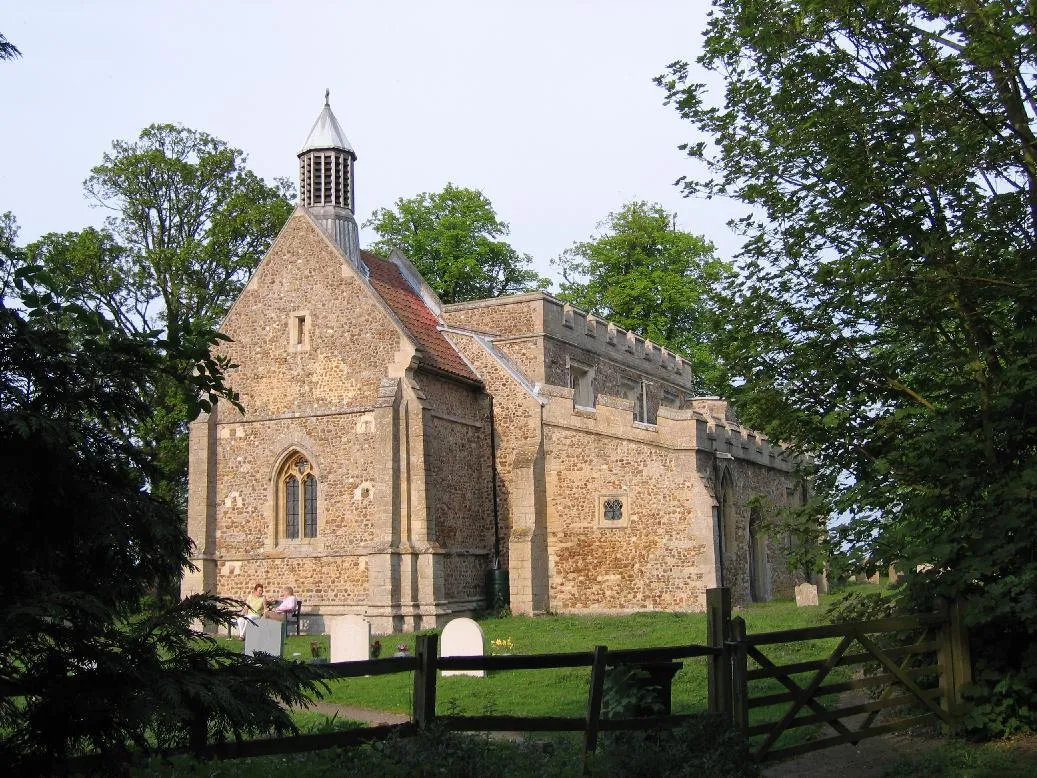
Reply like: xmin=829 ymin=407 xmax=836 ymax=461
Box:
xmin=555 ymin=202 xmax=731 ymax=388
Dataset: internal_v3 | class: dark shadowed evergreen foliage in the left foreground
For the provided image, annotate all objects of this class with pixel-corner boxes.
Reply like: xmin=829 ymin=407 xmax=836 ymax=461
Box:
xmin=0 ymin=267 xmax=320 ymax=770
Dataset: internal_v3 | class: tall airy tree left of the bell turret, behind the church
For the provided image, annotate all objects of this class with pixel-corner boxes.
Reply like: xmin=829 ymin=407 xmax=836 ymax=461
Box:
xmin=28 ymin=124 xmax=292 ymax=504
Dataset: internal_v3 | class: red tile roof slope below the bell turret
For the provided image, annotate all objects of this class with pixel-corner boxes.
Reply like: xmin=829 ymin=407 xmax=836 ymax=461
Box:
xmin=360 ymin=251 xmax=479 ymax=381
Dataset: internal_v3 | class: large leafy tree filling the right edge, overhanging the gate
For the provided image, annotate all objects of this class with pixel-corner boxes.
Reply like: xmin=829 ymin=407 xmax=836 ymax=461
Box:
xmin=660 ymin=0 xmax=1037 ymax=688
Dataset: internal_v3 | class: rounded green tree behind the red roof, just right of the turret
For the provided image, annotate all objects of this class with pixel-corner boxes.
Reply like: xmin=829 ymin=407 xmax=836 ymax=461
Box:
xmin=364 ymin=184 xmax=550 ymax=303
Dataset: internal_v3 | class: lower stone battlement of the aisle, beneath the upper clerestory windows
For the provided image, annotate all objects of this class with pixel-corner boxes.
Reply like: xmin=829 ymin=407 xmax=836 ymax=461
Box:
xmin=539 ymin=384 xmax=795 ymax=471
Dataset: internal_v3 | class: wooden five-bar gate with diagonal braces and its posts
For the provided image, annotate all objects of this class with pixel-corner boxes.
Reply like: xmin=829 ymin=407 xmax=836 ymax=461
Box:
xmin=709 ymin=589 xmax=972 ymax=761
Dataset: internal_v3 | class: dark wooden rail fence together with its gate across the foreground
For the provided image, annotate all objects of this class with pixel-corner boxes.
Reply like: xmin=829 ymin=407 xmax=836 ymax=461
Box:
xmin=50 ymin=588 xmax=971 ymax=769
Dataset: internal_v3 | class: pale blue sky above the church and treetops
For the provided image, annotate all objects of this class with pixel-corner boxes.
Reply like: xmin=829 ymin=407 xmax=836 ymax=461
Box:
xmin=0 ymin=0 xmax=738 ymax=282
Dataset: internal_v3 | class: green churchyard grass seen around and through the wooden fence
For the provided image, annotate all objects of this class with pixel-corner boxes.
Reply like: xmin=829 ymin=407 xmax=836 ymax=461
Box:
xmin=138 ymin=585 xmax=900 ymax=778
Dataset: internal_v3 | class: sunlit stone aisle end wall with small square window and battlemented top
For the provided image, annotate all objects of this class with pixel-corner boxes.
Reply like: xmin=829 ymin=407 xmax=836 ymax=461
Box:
xmin=544 ymin=387 xmax=716 ymax=612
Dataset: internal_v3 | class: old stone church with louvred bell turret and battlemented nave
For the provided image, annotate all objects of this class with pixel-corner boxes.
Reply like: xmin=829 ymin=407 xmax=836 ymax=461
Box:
xmin=183 ymin=103 xmax=806 ymax=632
